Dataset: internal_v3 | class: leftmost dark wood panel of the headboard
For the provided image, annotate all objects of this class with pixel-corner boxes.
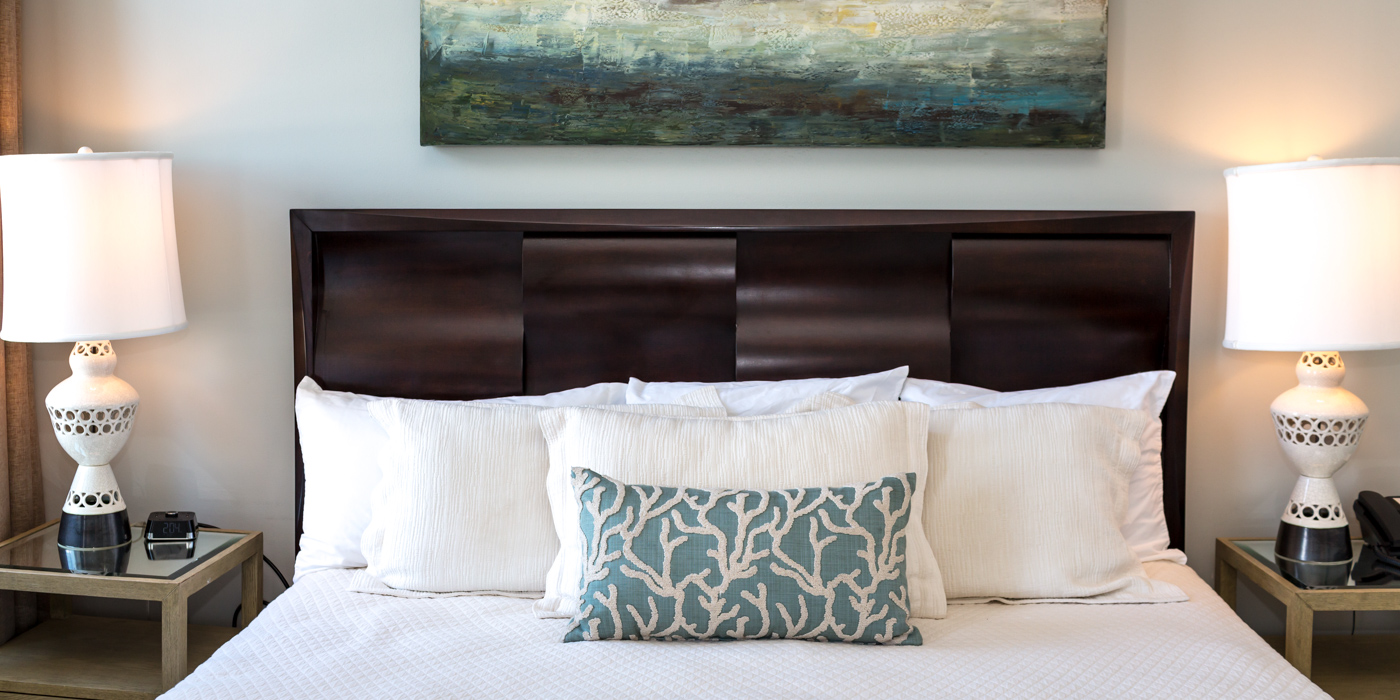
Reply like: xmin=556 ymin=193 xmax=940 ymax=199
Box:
xmin=298 ymin=231 xmax=522 ymax=399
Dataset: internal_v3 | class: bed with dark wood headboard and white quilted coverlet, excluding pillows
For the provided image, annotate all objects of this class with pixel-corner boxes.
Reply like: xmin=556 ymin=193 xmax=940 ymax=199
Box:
xmin=158 ymin=210 xmax=1326 ymax=699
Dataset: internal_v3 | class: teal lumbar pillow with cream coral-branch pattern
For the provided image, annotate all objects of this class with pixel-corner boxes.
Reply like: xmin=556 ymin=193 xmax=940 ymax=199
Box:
xmin=564 ymin=469 xmax=921 ymax=644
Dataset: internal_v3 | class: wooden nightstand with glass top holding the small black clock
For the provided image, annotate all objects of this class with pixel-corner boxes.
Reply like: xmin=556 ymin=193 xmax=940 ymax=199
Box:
xmin=0 ymin=521 xmax=262 ymax=699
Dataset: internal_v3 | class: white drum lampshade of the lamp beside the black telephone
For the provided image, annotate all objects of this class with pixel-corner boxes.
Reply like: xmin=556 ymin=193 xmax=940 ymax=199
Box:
xmin=1225 ymin=158 xmax=1400 ymax=353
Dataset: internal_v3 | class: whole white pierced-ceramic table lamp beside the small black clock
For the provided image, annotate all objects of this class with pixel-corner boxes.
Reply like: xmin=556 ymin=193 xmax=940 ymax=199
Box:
xmin=0 ymin=148 xmax=186 ymax=574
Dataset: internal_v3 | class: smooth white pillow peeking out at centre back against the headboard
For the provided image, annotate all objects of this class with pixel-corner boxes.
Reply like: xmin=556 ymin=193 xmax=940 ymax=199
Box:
xmin=627 ymin=367 xmax=909 ymax=414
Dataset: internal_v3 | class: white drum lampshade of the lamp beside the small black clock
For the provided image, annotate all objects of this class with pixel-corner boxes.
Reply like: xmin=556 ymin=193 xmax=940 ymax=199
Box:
xmin=0 ymin=153 xmax=186 ymax=343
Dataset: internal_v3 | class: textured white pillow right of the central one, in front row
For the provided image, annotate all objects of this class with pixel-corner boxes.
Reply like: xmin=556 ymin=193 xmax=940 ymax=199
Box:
xmin=924 ymin=403 xmax=1186 ymax=602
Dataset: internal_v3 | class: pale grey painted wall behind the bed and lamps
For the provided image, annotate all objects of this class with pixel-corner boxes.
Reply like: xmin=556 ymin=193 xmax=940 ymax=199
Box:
xmin=24 ymin=0 xmax=1400 ymax=630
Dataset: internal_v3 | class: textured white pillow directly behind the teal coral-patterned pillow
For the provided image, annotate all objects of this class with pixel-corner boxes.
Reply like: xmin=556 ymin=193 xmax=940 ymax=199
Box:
xmin=535 ymin=402 xmax=946 ymax=617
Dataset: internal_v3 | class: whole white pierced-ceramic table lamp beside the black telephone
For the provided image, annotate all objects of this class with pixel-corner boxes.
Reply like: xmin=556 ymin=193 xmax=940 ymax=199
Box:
xmin=1225 ymin=157 xmax=1400 ymax=585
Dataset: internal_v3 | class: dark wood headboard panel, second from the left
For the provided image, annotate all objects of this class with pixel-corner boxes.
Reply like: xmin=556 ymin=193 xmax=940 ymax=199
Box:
xmin=521 ymin=237 xmax=735 ymax=393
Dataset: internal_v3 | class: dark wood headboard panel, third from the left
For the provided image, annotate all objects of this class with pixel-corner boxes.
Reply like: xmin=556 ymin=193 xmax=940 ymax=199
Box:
xmin=735 ymin=231 xmax=951 ymax=379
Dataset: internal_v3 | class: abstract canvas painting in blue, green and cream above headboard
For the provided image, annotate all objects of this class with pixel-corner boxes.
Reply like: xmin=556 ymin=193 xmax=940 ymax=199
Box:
xmin=420 ymin=0 xmax=1107 ymax=148
